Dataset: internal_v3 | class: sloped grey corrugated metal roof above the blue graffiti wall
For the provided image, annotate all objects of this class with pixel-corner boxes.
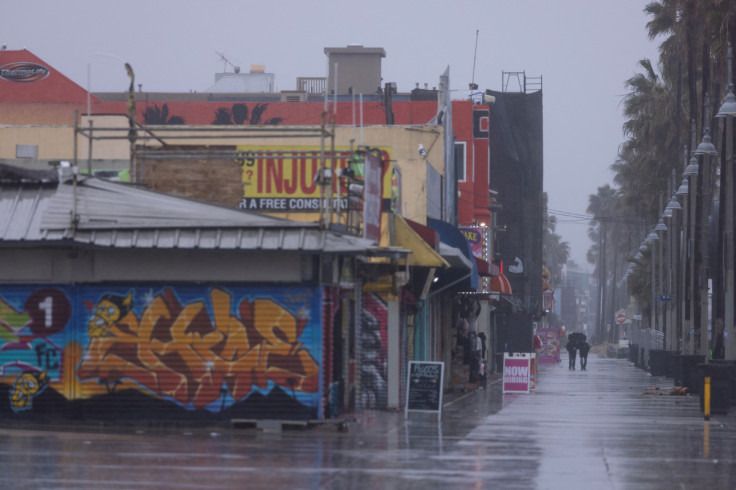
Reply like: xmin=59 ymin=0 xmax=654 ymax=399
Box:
xmin=0 ymin=172 xmax=388 ymax=255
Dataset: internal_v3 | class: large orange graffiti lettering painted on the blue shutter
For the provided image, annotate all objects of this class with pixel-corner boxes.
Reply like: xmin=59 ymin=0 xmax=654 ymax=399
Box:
xmin=77 ymin=289 xmax=319 ymax=408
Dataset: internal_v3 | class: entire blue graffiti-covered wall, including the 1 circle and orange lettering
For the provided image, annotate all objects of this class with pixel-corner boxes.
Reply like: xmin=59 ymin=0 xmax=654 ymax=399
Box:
xmin=0 ymin=285 xmax=323 ymax=422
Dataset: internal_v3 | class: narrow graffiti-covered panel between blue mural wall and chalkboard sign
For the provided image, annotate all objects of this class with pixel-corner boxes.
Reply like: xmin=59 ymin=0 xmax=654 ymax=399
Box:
xmin=360 ymin=293 xmax=388 ymax=408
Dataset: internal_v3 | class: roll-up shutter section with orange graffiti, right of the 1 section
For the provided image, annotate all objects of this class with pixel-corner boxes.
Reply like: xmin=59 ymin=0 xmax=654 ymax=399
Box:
xmin=76 ymin=284 xmax=322 ymax=422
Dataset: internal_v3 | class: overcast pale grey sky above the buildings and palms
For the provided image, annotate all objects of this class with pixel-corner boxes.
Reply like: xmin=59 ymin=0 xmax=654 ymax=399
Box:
xmin=0 ymin=0 xmax=657 ymax=265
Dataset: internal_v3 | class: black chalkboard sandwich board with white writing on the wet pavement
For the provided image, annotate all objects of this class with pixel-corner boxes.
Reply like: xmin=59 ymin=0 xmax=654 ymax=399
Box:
xmin=405 ymin=361 xmax=445 ymax=418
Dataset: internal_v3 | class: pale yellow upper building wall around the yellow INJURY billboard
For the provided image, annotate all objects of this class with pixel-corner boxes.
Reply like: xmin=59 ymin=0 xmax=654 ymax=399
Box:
xmin=0 ymin=115 xmax=444 ymax=223
